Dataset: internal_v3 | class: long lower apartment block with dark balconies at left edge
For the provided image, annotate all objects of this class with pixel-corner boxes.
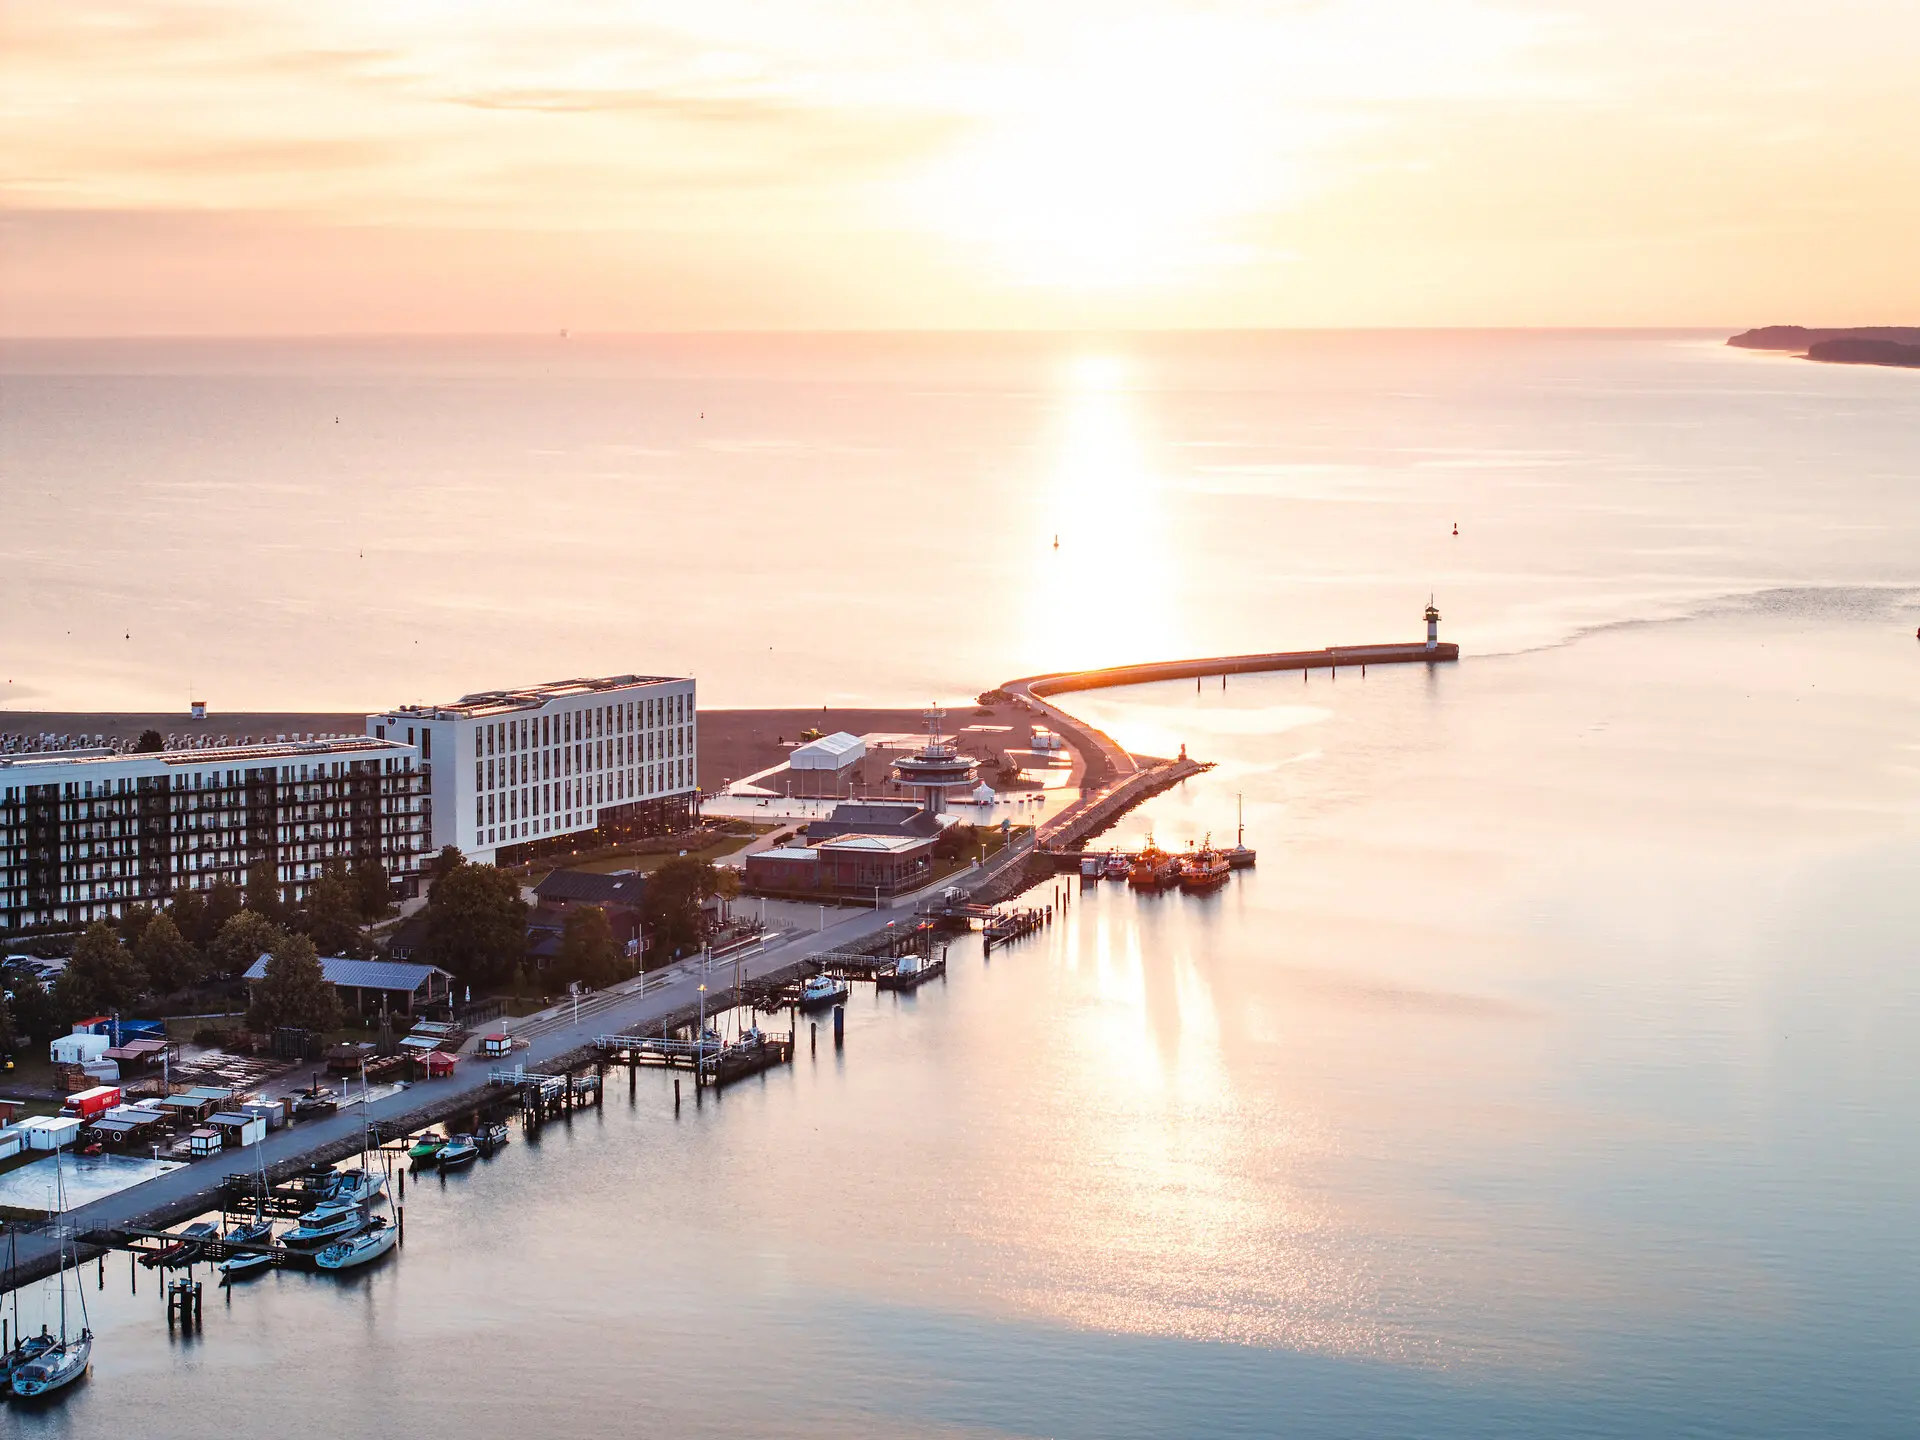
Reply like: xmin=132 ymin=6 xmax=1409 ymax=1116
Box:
xmin=0 ymin=735 xmax=428 ymax=933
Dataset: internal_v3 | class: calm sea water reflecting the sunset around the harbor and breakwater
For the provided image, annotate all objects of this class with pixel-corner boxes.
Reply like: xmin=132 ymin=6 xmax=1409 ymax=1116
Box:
xmin=4 ymin=336 xmax=1920 ymax=1440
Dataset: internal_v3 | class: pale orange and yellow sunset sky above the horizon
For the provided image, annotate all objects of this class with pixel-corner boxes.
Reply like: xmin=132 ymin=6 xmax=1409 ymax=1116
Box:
xmin=0 ymin=0 xmax=1920 ymax=336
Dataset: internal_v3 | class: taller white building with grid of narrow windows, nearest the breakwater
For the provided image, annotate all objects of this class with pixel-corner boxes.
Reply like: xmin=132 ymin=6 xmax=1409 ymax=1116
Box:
xmin=367 ymin=676 xmax=699 ymax=864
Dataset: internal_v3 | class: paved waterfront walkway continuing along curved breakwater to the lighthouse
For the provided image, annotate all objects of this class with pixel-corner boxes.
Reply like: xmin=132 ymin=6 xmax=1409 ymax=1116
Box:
xmin=12 ymin=616 xmax=1459 ymax=1286
